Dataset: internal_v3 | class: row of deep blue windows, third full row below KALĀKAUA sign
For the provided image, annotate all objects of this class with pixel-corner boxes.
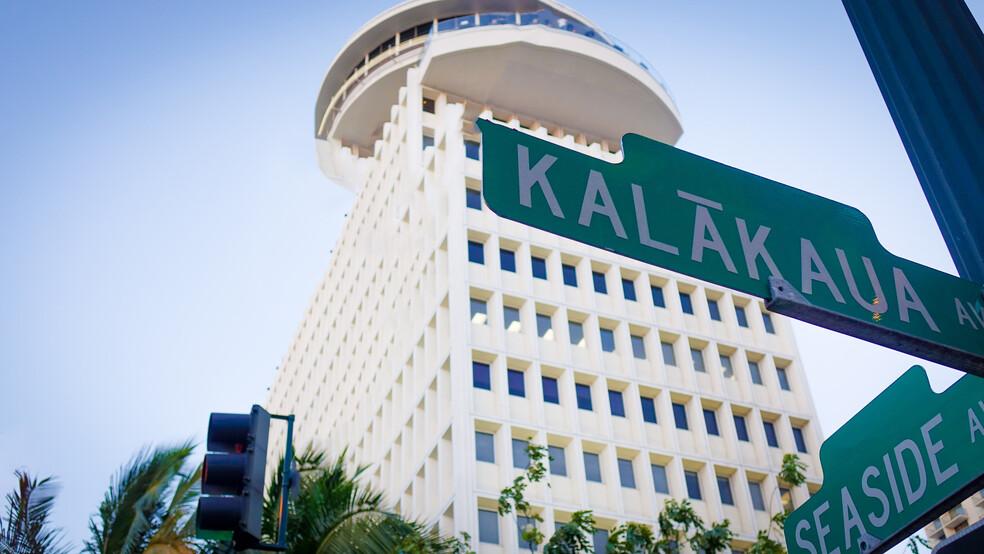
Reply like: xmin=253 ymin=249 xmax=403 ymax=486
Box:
xmin=472 ymin=361 xmax=808 ymax=454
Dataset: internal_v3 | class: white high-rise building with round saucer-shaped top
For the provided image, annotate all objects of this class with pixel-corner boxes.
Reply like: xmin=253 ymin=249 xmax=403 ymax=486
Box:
xmin=267 ymin=0 xmax=822 ymax=552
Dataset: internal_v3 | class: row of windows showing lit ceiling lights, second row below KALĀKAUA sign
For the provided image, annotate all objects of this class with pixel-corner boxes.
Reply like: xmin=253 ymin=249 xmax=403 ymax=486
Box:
xmin=471 ymin=297 xmax=792 ymax=391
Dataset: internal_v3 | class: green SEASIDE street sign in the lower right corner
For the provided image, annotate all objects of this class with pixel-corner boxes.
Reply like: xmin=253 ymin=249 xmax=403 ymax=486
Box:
xmin=785 ymin=366 xmax=984 ymax=554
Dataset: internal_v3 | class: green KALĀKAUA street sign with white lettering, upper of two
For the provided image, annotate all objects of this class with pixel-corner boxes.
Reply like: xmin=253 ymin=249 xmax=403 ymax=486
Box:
xmin=477 ymin=120 xmax=984 ymax=376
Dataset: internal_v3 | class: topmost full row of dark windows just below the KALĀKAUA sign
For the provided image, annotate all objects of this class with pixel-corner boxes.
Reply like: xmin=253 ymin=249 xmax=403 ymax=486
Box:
xmin=468 ymin=237 xmax=776 ymax=334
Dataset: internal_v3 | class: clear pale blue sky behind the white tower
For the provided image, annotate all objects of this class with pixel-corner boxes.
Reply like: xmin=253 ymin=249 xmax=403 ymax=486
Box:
xmin=0 ymin=0 xmax=982 ymax=543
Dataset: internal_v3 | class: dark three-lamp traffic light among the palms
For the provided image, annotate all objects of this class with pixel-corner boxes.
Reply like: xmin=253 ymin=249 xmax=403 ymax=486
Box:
xmin=197 ymin=405 xmax=270 ymax=550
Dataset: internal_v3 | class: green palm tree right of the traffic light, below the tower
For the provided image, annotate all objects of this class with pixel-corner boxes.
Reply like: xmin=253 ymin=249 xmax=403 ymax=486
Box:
xmin=263 ymin=450 xmax=455 ymax=554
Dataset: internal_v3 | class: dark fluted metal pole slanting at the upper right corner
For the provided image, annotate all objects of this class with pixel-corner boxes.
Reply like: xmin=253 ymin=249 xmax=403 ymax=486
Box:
xmin=843 ymin=0 xmax=984 ymax=283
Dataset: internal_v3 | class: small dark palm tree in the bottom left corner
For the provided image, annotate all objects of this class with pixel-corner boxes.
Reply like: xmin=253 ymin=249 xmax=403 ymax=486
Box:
xmin=0 ymin=470 xmax=68 ymax=554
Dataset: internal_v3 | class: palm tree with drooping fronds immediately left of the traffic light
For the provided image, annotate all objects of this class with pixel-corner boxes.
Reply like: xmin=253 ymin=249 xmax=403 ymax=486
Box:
xmin=83 ymin=442 xmax=201 ymax=554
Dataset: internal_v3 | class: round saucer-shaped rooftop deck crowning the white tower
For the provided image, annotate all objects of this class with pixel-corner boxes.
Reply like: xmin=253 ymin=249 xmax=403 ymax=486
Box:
xmin=314 ymin=0 xmax=682 ymax=184
